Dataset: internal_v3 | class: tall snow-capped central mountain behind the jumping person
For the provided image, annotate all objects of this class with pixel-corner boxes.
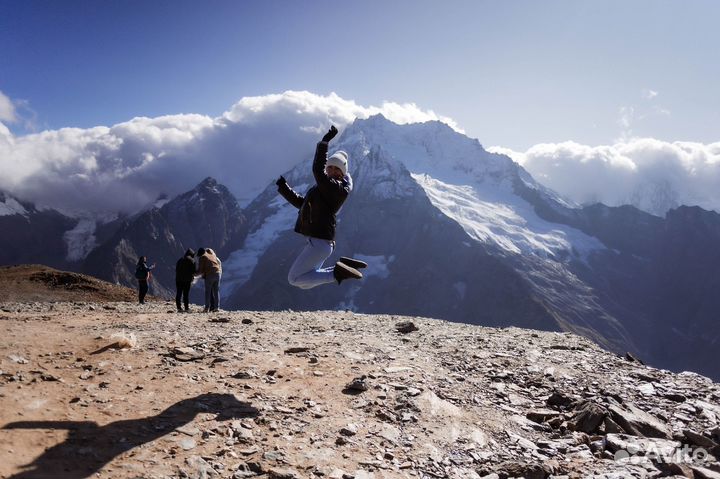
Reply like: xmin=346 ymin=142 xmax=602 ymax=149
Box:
xmin=226 ymin=116 xmax=636 ymax=351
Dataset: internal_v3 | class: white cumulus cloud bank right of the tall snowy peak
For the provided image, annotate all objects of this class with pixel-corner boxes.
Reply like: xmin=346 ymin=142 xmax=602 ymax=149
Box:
xmin=491 ymin=138 xmax=720 ymax=216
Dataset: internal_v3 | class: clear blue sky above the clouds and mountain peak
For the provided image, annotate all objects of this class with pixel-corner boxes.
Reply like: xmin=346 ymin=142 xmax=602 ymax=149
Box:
xmin=0 ymin=0 xmax=720 ymax=151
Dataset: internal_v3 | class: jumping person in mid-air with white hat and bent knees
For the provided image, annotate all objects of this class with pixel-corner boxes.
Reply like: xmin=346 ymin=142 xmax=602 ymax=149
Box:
xmin=275 ymin=126 xmax=367 ymax=289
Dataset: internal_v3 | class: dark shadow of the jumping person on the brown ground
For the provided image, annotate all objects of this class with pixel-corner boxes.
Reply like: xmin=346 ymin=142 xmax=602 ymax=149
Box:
xmin=3 ymin=393 xmax=260 ymax=479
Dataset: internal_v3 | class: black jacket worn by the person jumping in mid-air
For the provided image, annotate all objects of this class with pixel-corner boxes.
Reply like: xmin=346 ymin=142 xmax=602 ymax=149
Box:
xmin=278 ymin=141 xmax=352 ymax=241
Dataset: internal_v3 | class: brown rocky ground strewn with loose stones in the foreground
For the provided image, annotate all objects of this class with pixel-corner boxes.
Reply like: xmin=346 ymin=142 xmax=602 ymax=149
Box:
xmin=0 ymin=302 xmax=720 ymax=479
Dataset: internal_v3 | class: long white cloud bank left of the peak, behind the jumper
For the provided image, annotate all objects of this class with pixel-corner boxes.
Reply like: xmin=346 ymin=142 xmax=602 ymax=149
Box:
xmin=0 ymin=91 xmax=461 ymax=215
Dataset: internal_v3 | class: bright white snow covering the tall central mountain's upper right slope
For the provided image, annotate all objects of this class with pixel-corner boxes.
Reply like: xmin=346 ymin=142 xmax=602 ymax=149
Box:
xmin=338 ymin=117 xmax=605 ymax=261
